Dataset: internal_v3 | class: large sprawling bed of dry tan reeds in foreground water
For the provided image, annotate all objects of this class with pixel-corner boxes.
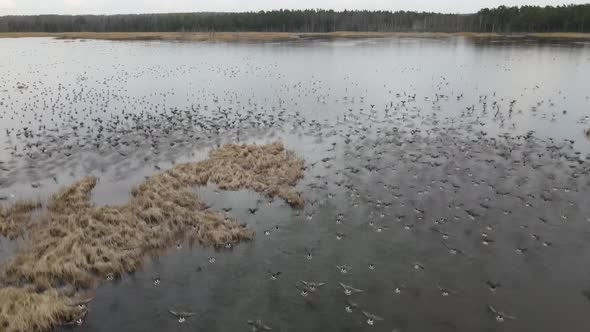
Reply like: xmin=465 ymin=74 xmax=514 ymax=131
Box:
xmin=0 ymin=143 xmax=304 ymax=331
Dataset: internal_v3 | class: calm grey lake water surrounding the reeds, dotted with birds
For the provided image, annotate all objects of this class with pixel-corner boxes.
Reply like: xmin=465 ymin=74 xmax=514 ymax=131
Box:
xmin=0 ymin=38 xmax=590 ymax=331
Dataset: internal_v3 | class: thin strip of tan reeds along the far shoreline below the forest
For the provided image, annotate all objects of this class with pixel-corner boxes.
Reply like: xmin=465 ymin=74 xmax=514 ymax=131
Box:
xmin=0 ymin=31 xmax=590 ymax=42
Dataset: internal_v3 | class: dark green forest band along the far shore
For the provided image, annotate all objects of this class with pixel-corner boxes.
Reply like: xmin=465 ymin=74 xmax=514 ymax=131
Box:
xmin=0 ymin=4 xmax=590 ymax=33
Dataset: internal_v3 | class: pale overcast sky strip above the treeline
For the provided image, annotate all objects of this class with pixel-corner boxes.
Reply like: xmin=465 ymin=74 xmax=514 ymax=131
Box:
xmin=0 ymin=0 xmax=590 ymax=15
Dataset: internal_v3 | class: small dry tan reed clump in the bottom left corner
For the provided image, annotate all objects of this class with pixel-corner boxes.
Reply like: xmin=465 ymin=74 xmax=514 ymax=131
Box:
xmin=0 ymin=287 xmax=82 ymax=332
